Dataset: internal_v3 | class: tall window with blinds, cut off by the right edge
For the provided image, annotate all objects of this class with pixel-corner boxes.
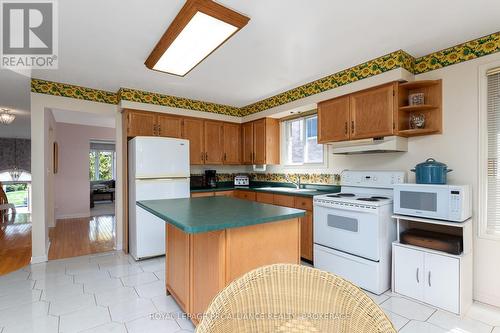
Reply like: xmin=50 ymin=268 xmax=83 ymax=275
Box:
xmin=481 ymin=68 xmax=500 ymax=235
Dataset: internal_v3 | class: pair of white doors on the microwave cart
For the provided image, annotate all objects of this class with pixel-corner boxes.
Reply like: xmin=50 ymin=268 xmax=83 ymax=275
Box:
xmin=394 ymin=246 xmax=460 ymax=313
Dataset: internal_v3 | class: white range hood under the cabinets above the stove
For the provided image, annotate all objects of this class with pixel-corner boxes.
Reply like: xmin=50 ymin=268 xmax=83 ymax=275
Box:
xmin=331 ymin=136 xmax=408 ymax=155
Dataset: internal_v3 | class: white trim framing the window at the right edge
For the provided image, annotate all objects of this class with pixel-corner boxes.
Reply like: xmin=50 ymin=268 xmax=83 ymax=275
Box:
xmin=477 ymin=61 xmax=500 ymax=241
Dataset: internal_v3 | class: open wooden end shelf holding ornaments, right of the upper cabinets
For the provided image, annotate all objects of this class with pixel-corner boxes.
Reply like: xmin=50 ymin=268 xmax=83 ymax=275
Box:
xmin=396 ymin=80 xmax=443 ymax=137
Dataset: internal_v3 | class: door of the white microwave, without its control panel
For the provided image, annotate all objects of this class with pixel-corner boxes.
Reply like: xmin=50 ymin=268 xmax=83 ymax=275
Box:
xmin=394 ymin=184 xmax=449 ymax=220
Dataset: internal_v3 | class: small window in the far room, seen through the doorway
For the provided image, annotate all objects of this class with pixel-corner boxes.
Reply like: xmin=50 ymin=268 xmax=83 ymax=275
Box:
xmin=89 ymin=142 xmax=116 ymax=180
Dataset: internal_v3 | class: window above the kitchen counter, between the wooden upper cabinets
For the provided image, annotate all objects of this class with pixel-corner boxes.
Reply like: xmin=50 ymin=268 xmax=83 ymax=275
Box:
xmin=283 ymin=115 xmax=324 ymax=165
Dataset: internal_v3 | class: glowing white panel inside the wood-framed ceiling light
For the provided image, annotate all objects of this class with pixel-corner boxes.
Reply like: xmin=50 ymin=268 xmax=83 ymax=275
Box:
xmin=153 ymin=12 xmax=238 ymax=76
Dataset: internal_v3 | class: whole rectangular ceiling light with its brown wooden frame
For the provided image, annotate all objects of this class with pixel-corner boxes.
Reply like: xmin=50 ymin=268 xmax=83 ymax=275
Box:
xmin=145 ymin=0 xmax=250 ymax=76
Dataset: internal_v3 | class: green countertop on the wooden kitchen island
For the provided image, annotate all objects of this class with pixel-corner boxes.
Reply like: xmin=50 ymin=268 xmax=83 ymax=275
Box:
xmin=137 ymin=197 xmax=305 ymax=234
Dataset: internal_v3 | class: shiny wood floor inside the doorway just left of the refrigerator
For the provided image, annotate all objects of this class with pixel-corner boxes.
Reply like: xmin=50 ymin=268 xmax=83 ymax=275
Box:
xmin=49 ymin=215 xmax=116 ymax=260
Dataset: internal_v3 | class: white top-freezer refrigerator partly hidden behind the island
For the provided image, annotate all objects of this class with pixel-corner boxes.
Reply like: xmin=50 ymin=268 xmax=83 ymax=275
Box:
xmin=128 ymin=137 xmax=190 ymax=260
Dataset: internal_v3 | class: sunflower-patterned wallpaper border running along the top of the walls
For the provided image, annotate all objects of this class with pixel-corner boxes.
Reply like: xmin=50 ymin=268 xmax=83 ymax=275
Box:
xmin=31 ymin=32 xmax=500 ymax=117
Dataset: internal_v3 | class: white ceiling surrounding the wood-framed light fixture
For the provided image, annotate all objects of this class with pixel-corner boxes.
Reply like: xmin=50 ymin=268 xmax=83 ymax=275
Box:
xmin=0 ymin=0 xmax=500 ymax=126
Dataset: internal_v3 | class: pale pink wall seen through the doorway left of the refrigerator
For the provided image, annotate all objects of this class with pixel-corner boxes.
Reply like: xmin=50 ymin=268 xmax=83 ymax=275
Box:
xmin=54 ymin=123 xmax=115 ymax=218
